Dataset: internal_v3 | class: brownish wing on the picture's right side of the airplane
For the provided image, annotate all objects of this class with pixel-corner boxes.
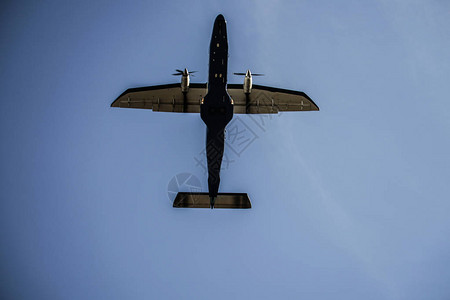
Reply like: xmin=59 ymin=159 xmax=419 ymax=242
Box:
xmin=227 ymin=84 xmax=319 ymax=114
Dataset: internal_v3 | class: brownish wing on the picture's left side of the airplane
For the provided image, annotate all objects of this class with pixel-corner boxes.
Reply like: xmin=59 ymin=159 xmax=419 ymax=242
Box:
xmin=111 ymin=83 xmax=207 ymax=113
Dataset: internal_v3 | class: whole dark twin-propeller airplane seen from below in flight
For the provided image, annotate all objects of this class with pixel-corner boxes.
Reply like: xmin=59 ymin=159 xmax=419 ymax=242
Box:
xmin=111 ymin=14 xmax=319 ymax=209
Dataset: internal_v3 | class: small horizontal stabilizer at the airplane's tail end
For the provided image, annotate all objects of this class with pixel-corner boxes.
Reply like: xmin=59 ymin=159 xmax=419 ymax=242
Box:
xmin=173 ymin=192 xmax=252 ymax=208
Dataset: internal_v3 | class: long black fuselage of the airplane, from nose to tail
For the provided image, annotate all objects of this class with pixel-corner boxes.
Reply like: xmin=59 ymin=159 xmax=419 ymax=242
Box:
xmin=200 ymin=15 xmax=233 ymax=207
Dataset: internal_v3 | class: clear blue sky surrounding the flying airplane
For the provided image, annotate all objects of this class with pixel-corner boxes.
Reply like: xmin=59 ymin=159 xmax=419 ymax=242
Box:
xmin=0 ymin=1 xmax=450 ymax=299
